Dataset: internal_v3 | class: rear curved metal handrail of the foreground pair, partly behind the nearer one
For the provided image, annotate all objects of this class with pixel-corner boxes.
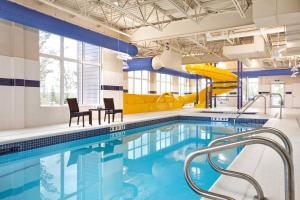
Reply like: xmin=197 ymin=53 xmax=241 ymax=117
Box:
xmin=207 ymin=127 xmax=293 ymax=199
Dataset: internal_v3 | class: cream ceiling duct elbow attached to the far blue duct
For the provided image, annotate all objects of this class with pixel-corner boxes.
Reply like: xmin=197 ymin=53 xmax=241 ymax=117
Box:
xmin=152 ymin=43 xmax=182 ymax=71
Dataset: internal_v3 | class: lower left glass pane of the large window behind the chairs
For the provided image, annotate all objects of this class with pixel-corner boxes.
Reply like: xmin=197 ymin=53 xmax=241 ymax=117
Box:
xmin=40 ymin=57 xmax=60 ymax=105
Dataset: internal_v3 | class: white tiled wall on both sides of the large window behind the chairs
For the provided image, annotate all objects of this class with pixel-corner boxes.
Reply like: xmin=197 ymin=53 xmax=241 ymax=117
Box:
xmin=0 ymin=21 xmax=123 ymax=130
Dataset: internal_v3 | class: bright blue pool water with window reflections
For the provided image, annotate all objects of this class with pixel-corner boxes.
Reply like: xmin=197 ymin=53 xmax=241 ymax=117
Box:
xmin=0 ymin=121 xmax=259 ymax=200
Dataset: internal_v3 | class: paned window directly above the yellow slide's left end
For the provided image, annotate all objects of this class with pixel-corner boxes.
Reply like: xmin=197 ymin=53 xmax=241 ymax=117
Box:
xmin=128 ymin=71 xmax=150 ymax=94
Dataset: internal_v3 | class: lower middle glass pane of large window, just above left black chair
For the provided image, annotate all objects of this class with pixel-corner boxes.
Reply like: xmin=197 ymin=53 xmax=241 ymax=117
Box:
xmin=64 ymin=61 xmax=78 ymax=103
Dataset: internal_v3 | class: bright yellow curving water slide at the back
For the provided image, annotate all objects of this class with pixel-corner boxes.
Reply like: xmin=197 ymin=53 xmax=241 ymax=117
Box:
xmin=123 ymin=64 xmax=237 ymax=114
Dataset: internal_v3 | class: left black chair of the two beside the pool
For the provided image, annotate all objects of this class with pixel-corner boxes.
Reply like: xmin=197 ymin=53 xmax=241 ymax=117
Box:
xmin=67 ymin=98 xmax=92 ymax=127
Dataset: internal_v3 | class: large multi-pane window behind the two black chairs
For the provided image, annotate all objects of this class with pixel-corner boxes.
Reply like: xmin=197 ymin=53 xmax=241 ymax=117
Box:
xmin=39 ymin=31 xmax=101 ymax=105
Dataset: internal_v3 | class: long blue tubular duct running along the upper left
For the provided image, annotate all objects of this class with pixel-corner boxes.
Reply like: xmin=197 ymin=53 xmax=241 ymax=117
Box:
xmin=0 ymin=0 xmax=138 ymax=56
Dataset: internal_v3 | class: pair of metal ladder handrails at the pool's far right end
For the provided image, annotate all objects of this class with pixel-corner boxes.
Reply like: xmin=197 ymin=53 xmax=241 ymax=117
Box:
xmin=233 ymin=93 xmax=283 ymax=124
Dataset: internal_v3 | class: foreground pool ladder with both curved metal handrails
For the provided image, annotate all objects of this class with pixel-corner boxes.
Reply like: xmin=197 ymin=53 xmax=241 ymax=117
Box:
xmin=184 ymin=127 xmax=295 ymax=200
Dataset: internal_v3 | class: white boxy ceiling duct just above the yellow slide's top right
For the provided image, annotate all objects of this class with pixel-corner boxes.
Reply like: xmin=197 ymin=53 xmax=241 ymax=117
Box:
xmin=223 ymin=36 xmax=268 ymax=60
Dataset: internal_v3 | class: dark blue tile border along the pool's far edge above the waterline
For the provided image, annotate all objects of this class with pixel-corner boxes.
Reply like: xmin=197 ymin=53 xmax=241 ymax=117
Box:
xmin=0 ymin=116 xmax=268 ymax=156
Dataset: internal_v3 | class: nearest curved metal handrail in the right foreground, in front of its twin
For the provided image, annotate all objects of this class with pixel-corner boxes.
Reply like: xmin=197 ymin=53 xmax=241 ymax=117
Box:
xmin=184 ymin=137 xmax=295 ymax=200
